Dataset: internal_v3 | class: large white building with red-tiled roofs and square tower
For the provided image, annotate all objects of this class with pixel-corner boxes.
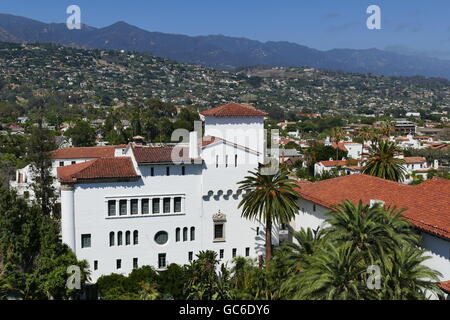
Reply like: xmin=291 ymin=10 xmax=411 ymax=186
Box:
xmin=57 ymin=103 xmax=278 ymax=281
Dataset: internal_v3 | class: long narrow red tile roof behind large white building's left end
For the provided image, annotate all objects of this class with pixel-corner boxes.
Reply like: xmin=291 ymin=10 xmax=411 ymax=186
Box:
xmin=50 ymin=145 xmax=126 ymax=159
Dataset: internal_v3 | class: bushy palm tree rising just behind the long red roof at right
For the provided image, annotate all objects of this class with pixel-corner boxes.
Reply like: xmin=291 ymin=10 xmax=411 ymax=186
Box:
xmin=362 ymin=140 xmax=406 ymax=182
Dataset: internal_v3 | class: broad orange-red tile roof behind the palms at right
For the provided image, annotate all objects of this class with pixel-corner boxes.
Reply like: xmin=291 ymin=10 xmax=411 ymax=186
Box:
xmin=298 ymin=174 xmax=450 ymax=239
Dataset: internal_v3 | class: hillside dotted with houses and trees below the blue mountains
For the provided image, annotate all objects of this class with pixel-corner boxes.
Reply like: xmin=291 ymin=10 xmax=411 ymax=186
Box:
xmin=0 ymin=43 xmax=450 ymax=120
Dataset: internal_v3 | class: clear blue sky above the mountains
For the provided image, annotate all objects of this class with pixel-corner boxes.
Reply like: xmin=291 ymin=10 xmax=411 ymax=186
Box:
xmin=0 ymin=0 xmax=450 ymax=59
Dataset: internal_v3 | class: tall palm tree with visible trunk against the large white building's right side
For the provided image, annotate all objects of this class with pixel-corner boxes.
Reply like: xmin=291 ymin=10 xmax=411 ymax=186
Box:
xmin=238 ymin=170 xmax=299 ymax=263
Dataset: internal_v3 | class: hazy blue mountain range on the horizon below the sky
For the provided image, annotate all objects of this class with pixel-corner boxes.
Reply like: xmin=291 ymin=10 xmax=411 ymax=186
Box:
xmin=0 ymin=14 xmax=450 ymax=79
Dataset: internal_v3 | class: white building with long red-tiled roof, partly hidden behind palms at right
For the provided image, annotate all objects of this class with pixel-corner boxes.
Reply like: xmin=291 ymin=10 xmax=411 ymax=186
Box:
xmin=292 ymin=174 xmax=450 ymax=298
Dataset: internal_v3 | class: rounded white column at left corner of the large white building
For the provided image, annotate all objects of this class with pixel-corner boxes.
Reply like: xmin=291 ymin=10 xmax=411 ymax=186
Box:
xmin=61 ymin=184 xmax=75 ymax=252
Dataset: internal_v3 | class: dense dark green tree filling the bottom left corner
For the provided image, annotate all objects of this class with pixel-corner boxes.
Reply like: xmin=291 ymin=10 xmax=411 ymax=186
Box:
xmin=0 ymin=188 xmax=89 ymax=299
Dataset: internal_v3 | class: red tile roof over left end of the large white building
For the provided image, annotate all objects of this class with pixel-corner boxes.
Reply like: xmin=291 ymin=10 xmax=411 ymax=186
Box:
xmin=57 ymin=157 xmax=140 ymax=183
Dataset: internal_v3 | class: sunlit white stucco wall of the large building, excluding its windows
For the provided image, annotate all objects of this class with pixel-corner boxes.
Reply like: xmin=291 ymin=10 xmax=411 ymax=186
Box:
xmin=63 ymin=143 xmax=268 ymax=281
